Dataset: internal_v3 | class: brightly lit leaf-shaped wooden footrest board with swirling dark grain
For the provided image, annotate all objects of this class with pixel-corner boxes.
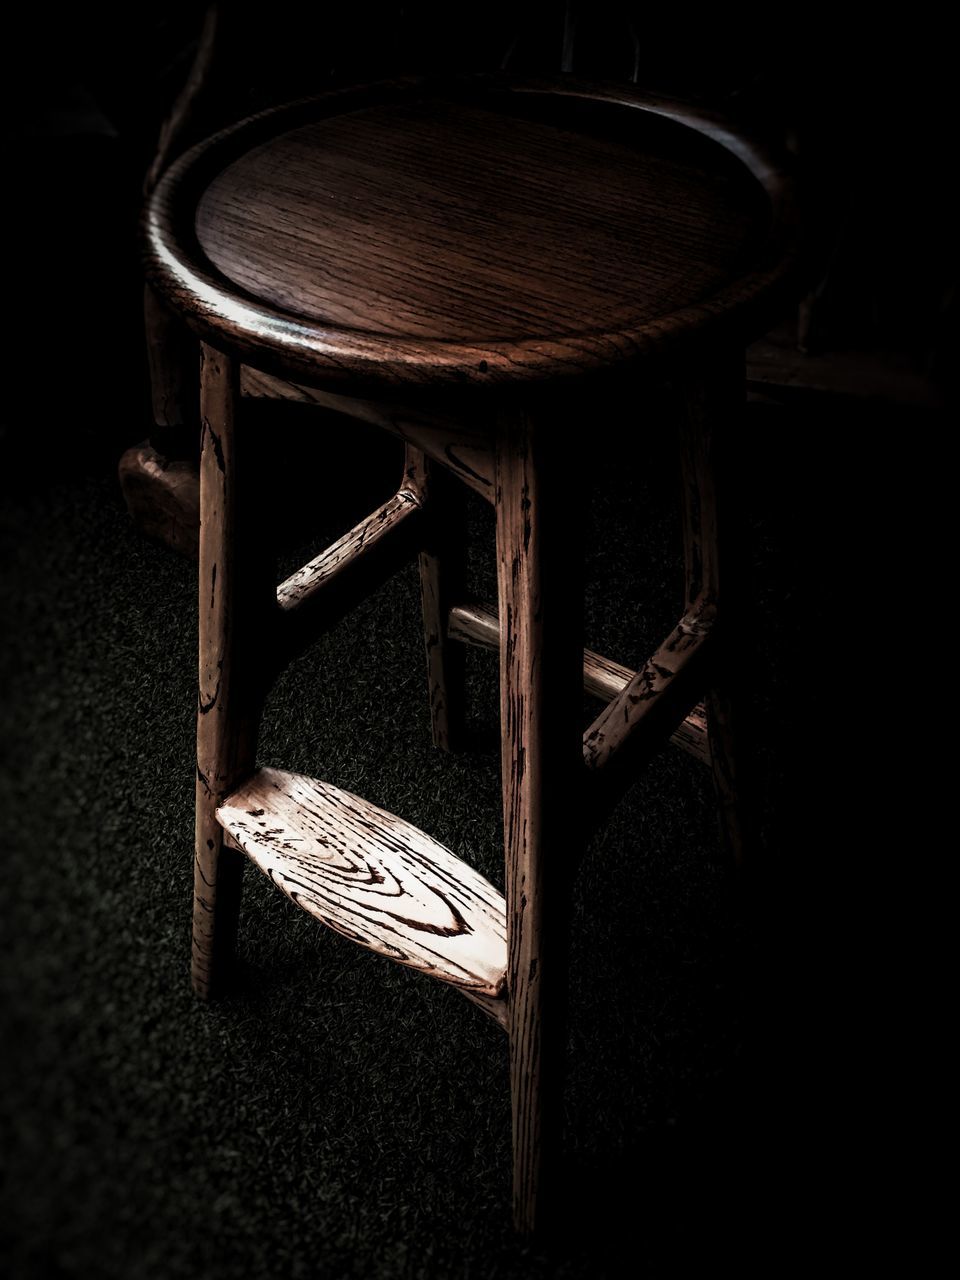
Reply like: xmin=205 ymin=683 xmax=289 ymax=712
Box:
xmin=216 ymin=769 xmax=507 ymax=998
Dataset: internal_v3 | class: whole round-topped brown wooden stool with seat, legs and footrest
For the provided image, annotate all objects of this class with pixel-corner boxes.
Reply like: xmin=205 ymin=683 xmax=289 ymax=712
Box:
xmin=146 ymin=78 xmax=796 ymax=1230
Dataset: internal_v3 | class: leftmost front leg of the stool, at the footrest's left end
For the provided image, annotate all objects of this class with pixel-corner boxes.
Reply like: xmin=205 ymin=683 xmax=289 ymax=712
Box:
xmin=192 ymin=346 xmax=275 ymax=997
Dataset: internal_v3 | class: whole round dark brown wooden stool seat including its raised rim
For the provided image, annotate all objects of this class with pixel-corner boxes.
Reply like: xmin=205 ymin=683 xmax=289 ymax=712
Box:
xmin=146 ymin=79 xmax=792 ymax=387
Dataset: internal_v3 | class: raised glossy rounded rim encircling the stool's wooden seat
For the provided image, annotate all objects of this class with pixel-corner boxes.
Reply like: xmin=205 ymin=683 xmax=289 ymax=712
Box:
xmin=142 ymin=76 xmax=799 ymax=392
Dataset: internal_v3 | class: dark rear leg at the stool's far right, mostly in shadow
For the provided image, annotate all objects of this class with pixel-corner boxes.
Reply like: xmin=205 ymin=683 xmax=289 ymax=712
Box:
xmin=680 ymin=346 xmax=754 ymax=864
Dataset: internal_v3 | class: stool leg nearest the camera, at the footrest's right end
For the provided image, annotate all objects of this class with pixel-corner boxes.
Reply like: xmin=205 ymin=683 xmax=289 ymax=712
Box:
xmin=497 ymin=413 xmax=584 ymax=1233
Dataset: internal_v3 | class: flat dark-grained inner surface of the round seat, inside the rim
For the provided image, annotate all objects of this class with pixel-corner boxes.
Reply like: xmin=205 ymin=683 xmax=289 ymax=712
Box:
xmin=196 ymin=99 xmax=765 ymax=343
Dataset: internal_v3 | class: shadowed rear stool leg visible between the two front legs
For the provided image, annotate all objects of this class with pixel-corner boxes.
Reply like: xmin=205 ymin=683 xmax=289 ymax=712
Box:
xmin=407 ymin=445 xmax=466 ymax=751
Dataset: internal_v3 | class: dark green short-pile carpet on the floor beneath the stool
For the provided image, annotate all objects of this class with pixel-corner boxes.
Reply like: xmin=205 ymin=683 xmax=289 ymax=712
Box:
xmin=0 ymin=384 xmax=829 ymax=1280
